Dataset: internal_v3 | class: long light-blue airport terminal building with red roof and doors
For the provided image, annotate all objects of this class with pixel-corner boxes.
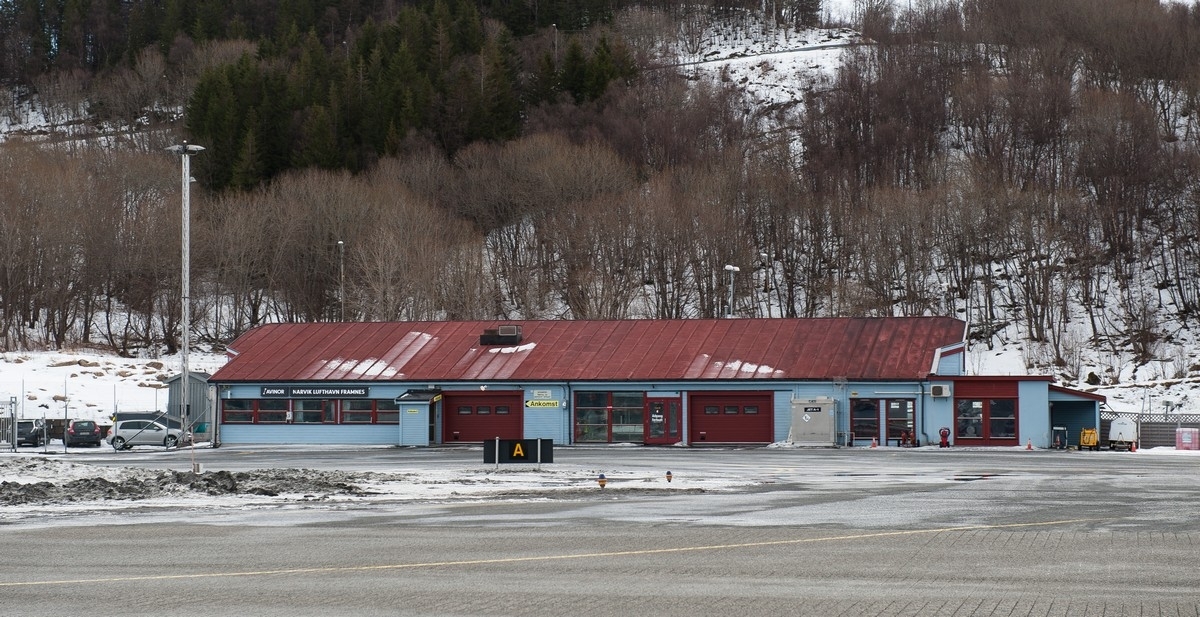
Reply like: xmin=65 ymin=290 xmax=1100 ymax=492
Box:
xmin=201 ymin=317 xmax=1104 ymax=447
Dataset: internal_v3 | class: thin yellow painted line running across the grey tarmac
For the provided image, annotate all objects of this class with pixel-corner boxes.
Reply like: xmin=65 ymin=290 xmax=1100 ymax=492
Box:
xmin=0 ymin=519 xmax=1105 ymax=588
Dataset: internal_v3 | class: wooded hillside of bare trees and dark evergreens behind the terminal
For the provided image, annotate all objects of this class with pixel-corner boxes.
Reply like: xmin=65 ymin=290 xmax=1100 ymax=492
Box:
xmin=0 ymin=0 xmax=1200 ymax=381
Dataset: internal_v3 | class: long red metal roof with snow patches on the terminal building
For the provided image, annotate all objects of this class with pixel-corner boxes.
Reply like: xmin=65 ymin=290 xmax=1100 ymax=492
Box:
xmin=211 ymin=317 xmax=965 ymax=382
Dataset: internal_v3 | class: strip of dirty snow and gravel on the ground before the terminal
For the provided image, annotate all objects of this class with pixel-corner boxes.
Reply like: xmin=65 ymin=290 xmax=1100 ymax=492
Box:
xmin=0 ymin=456 xmax=710 ymax=521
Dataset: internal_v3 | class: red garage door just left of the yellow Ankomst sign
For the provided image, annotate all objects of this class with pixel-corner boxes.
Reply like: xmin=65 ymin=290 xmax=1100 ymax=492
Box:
xmin=442 ymin=390 xmax=524 ymax=443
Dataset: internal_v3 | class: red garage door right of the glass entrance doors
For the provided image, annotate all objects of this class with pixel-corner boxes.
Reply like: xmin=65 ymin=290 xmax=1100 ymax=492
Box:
xmin=688 ymin=393 xmax=775 ymax=443
